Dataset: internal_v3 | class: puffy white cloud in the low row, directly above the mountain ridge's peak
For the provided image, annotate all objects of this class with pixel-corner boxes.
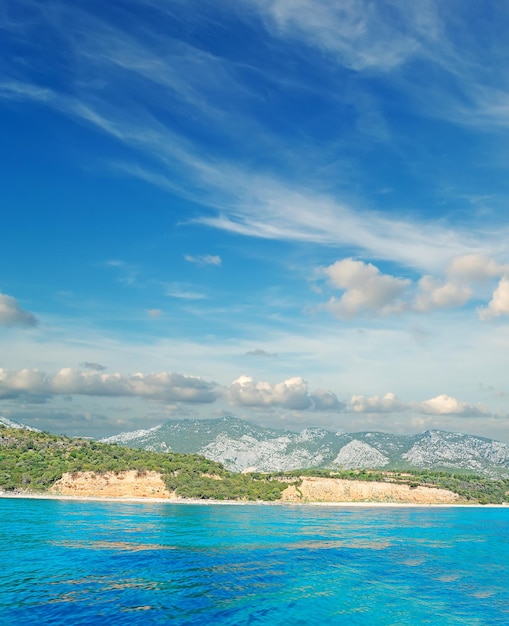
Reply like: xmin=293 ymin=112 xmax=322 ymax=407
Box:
xmin=227 ymin=376 xmax=342 ymax=411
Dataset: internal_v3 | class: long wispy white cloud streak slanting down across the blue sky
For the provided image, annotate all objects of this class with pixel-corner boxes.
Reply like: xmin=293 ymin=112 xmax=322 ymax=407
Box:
xmin=0 ymin=73 xmax=488 ymax=270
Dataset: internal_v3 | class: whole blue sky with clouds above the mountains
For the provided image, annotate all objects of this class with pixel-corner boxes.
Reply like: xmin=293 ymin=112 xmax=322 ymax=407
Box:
xmin=0 ymin=0 xmax=509 ymax=442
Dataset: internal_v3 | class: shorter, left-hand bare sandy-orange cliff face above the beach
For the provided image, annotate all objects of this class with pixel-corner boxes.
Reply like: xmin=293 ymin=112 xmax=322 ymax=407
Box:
xmin=50 ymin=470 xmax=175 ymax=498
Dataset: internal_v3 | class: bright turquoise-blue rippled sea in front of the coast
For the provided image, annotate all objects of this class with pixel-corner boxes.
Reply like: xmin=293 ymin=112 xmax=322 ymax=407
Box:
xmin=0 ymin=498 xmax=509 ymax=626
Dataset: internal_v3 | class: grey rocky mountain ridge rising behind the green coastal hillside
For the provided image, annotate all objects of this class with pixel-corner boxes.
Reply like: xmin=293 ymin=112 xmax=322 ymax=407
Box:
xmin=101 ymin=416 xmax=509 ymax=477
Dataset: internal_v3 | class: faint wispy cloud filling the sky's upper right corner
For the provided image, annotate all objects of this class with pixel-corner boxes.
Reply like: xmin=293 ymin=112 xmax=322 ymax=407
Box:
xmin=245 ymin=0 xmax=509 ymax=131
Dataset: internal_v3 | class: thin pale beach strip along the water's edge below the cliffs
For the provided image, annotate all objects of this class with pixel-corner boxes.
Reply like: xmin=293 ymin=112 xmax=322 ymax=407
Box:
xmin=0 ymin=492 xmax=509 ymax=509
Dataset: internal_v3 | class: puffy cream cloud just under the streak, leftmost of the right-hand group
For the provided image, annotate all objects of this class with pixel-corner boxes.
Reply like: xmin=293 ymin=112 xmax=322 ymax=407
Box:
xmin=323 ymin=258 xmax=411 ymax=319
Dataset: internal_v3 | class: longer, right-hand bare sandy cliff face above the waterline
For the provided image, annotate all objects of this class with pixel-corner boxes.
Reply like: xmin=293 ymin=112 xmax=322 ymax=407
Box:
xmin=281 ymin=477 xmax=462 ymax=504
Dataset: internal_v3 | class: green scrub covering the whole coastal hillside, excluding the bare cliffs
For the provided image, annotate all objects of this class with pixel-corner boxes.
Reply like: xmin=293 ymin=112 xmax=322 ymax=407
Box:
xmin=0 ymin=427 xmax=509 ymax=504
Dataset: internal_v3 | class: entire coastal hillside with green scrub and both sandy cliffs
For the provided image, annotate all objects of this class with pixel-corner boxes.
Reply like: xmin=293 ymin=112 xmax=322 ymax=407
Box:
xmin=0 ymin=426 xmax=509 ymax=504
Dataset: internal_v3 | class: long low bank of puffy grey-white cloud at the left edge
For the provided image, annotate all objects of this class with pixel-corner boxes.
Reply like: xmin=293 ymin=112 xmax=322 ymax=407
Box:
xmin=0 ymin=367 xmax=218 ymax=403
